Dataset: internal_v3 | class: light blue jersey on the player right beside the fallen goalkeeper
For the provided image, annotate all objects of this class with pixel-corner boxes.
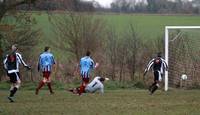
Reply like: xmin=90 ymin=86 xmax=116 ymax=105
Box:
xmin=80 ymin=56 xmax=94 ymax=78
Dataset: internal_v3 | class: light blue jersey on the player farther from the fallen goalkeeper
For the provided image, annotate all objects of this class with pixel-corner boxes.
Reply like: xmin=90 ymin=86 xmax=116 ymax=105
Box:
xmin=38 ymin=52 xmax=55 ymax=71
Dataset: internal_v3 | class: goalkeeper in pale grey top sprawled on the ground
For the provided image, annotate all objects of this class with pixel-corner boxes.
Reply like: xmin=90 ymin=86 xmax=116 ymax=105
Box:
xmin=69 ymin=76 xmax=109 ymax=94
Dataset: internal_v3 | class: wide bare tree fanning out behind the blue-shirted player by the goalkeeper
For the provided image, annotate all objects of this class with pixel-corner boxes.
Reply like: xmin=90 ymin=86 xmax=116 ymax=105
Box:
xmin=53 ymin=12 xmax=104 ymax=61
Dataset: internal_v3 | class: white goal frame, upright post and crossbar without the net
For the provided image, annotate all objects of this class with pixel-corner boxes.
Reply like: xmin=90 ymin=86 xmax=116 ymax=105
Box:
xmin=165 ymin=26 xmax=200 ymax=91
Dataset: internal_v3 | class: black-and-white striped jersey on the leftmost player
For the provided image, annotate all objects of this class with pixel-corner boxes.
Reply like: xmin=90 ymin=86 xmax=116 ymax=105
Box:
xmin=3 ymin=52 xmax=28 ymax=73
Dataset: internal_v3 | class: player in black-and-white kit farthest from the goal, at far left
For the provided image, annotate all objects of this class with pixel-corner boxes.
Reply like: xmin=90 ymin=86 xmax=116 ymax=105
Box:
xmin=3 ymin=44 xmax=31 ymax=102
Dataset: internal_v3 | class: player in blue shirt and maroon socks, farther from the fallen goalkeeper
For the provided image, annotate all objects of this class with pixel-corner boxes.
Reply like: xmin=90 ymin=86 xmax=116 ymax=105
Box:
xmin=35 ymin=46 xmax=55 ymax=95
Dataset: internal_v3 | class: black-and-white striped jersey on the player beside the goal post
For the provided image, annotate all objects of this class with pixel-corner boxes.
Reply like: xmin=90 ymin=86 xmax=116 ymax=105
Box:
xmin=145 ymin=57 xmax=168 ymax=74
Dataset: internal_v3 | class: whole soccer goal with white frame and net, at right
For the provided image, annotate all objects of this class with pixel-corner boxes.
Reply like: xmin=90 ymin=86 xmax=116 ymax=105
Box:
xmin=164 ymin=26 xmax=200 ymax=91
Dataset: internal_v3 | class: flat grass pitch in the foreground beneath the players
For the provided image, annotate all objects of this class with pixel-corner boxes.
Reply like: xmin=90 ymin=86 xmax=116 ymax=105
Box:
xmin=0 ymin=90 xmax=200 ymax=115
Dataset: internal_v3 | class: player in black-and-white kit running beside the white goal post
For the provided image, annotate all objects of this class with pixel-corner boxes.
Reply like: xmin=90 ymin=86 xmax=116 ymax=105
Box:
xmin=144 ymin=52 xmax=168 ymax=94
